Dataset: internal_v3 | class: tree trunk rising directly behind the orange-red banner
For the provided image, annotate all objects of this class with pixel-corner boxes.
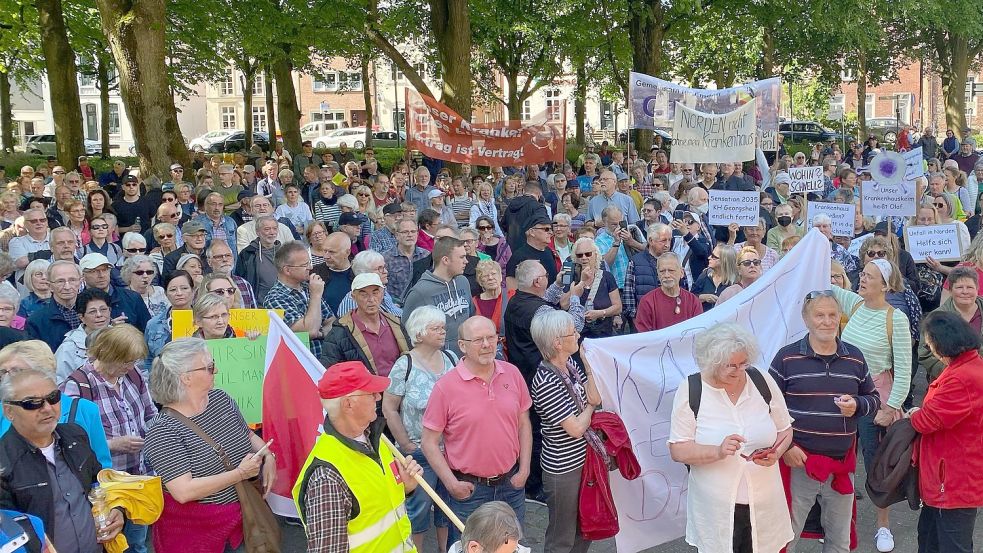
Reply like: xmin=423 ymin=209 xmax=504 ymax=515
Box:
xmin=430 ymin=0 xmax=474 ymax=120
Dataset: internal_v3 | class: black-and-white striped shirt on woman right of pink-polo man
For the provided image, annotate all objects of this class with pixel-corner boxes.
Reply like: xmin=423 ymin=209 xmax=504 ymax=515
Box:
xmin=530 ymin=363 xmax=587 ymax=474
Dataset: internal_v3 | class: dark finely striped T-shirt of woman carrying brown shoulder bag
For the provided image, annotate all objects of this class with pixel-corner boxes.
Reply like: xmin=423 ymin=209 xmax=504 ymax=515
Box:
xmin=143 ymin=388 xmax=253 ymax=504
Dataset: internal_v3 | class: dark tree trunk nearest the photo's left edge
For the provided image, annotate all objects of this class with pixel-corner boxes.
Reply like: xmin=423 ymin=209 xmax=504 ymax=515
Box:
xmin=36 ymin=0 xmax=84 ymax=167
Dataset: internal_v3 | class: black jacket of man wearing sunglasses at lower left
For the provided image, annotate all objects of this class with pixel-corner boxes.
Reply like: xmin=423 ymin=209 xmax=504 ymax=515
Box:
xmin=0 ymin=423 xmax=102 ymax=528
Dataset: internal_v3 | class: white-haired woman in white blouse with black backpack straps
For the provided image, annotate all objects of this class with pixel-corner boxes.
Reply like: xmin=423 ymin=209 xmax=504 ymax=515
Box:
xmin=668 ymin=323 xmax=792 ymax=553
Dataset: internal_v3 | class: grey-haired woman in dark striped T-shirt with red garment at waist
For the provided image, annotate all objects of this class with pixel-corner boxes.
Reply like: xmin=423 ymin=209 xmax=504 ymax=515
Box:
xmin=143 ymin=338 xmax=276 ymax=553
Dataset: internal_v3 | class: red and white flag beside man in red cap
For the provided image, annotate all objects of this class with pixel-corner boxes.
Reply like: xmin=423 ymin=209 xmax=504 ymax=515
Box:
xmin=263 ymin=311 xmax=324 ymax=518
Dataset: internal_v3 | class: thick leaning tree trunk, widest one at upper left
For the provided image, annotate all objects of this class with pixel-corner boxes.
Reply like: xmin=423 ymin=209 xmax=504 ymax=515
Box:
xmin=97 ymin=0 xmax=191 ymax=179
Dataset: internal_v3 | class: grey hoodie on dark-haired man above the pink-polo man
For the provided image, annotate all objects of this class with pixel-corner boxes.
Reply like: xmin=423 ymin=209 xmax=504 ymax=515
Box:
xmin=400 ymin=271 xmax=475 ymax=357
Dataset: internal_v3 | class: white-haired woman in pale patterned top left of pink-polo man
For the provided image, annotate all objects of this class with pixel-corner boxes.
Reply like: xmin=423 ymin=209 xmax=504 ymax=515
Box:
xmin=384 ymin=304 xmax=457 ymax=551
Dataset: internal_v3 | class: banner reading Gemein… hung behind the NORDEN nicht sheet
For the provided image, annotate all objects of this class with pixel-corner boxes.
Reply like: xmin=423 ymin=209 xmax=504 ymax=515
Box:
xmin=629 ymin=72 xmax=782 ymax=152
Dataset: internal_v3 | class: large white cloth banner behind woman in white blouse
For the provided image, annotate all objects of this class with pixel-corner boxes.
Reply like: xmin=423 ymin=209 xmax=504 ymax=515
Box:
xmin=584 ymin=229 xmax=830 ymax=553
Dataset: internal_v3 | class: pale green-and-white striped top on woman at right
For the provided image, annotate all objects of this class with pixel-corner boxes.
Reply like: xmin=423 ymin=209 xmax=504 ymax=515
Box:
xmin=832 ymin=286 xmax=911 ymax=409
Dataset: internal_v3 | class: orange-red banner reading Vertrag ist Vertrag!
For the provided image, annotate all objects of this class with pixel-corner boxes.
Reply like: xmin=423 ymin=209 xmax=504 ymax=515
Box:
xmin=406 ymin=89 xmax=567 ymax=166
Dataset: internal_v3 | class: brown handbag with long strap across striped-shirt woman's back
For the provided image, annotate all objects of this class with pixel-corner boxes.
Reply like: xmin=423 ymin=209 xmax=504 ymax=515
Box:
xmin=161 ymin=407 xmax=280 ymax=553
